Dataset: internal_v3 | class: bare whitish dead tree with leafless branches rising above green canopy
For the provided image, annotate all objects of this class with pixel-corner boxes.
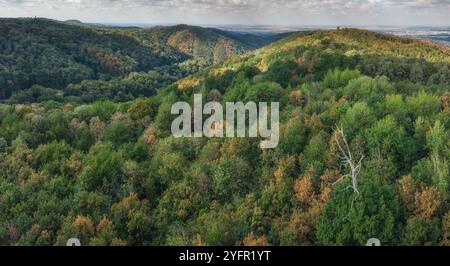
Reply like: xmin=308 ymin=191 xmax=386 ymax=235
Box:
xmin=333 ymin=127 xmax=364 ymax=207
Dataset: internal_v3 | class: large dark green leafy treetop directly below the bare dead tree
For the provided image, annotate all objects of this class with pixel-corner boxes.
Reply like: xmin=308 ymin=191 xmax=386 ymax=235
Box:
xmin=317 ymin=174 xmax=400 ymax=245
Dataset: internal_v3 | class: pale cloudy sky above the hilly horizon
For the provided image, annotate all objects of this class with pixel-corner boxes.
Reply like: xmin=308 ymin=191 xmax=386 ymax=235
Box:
xmin=0 ymin=0 xmax=450 ymax=26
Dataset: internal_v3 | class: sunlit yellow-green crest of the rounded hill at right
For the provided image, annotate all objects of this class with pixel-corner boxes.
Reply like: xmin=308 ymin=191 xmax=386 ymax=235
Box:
xmin=246 ymin=29 xmax=450 ymax=68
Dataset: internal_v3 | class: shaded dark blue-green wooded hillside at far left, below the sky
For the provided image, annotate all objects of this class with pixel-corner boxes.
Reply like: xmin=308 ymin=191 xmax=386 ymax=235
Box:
xmin=0 ymin=19 xmax=186 ymax=97
